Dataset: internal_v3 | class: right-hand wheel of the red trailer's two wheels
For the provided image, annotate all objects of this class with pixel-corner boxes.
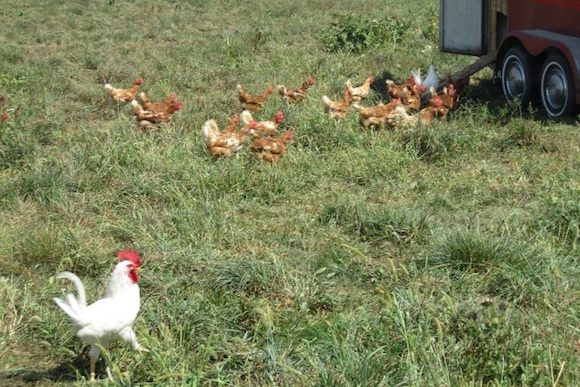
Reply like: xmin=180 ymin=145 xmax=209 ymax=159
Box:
xmin=540 ymin=54 xmax=575 ymax=118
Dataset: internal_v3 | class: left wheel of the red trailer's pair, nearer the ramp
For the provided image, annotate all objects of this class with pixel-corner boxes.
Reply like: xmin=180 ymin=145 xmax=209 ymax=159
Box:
xmin=501 ymin=47 xmax=534 ymax=106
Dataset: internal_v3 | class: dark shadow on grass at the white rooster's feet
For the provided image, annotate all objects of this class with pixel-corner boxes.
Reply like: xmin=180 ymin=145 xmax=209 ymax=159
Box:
xmin=0 ymin=347 xmax=106 ymax=387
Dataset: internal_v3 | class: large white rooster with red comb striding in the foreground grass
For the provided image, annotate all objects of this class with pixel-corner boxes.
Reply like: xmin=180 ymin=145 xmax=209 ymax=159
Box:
xmin=53 ymin=249 xmax=149 ymax=380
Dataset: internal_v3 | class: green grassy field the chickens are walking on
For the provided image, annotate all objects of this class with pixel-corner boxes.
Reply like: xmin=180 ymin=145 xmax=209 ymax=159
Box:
xmin=0 ymin=0 xmax=580 ymax=386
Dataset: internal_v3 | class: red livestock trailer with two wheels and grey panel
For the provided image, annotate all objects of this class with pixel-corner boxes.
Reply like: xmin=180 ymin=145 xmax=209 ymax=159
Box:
xmin=439 ymin=0 xmax=580 ymax=118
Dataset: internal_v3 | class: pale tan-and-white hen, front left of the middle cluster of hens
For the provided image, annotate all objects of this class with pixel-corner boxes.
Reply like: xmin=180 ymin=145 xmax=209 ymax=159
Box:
xmin=201 ymin=115 xmax=257 ymax=158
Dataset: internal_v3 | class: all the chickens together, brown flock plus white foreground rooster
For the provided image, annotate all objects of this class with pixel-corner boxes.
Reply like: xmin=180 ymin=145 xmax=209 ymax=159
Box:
xmin=49 ymin=67 xmax=456 ymax=380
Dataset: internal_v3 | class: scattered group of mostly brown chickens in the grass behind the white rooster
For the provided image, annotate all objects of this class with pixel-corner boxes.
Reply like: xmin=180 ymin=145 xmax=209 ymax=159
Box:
xmin=105 ymin=65 xmax=457 ymax=163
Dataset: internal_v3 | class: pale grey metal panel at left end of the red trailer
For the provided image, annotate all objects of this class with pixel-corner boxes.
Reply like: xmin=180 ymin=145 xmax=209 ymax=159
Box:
xmin=439 ymin=0 xmax=486 ymax=56
